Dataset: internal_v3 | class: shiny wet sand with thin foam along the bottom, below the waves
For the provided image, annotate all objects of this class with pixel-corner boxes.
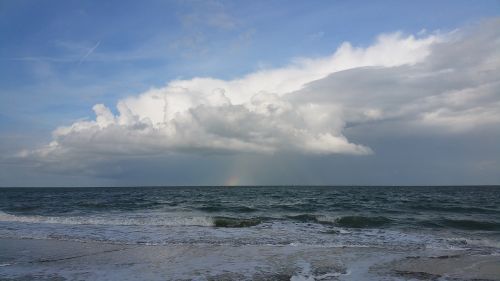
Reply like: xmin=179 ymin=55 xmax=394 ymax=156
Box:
xmin=0 ymin=239 xmax=500 ymax=280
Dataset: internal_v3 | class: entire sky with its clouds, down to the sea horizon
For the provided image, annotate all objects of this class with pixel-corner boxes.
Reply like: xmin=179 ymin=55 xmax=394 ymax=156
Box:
xmin=0 ymin=0 xmax=500 ymax=187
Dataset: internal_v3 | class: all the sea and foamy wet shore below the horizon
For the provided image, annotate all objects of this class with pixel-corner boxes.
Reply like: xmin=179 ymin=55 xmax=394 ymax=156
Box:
xmin=0 ymin=187 xmax=500 ymax=281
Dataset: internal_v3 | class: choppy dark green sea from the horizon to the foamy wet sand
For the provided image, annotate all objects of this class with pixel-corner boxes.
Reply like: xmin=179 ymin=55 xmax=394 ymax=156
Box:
xmin=0 ymin=186 xmax=500 ymax=249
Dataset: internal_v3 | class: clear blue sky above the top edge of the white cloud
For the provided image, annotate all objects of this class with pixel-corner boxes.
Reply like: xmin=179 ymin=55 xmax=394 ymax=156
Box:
xmin=0 ymin=0 xmax=500 ymax=185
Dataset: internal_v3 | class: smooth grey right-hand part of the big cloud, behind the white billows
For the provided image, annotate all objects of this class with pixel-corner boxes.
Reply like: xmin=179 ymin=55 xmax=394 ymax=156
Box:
xmin=289 ymin=20 xmax=500 ymax=133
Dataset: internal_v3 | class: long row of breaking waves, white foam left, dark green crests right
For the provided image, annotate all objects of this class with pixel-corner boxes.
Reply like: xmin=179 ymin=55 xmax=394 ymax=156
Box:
xmin=0 ymin=211 xmax=500 ymax=231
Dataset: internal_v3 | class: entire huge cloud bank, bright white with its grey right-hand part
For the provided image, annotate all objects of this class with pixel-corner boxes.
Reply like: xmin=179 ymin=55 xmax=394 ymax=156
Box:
xmin=20 ymin=20 xmax=500 ymax=169
